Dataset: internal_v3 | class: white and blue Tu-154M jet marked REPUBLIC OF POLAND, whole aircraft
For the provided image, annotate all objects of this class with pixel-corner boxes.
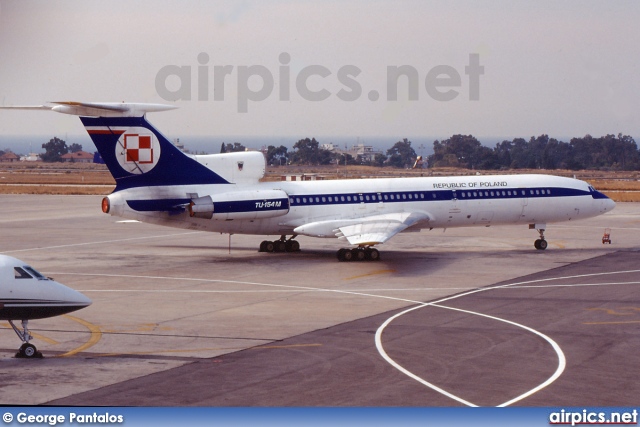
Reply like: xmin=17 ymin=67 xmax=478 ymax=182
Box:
xmin=2 ymin=102 xmax=615 ymax=261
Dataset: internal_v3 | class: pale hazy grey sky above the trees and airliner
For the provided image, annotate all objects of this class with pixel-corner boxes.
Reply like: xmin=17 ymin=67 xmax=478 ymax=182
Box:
xmin=0 ymin=0 xmax=640 ymax=146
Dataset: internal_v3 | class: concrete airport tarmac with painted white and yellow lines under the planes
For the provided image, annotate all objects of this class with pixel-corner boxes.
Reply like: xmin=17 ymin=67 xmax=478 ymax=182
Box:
xmin=0 ymin=195 xmax=640 ymax=406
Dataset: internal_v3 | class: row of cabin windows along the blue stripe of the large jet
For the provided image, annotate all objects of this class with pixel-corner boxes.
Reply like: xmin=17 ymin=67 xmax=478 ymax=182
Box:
xmin=290 ymin=189 xmax=551 ymax=204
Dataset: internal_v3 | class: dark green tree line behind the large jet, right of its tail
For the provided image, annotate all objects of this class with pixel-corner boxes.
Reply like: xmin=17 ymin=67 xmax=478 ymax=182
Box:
xmin=262 ymin=134 xmax=640 ymax=170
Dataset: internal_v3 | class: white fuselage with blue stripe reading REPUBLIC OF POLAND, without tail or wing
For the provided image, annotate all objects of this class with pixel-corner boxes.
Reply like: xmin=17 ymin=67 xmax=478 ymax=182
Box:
xmin=104 ymin=175 xmax=615 ymax=241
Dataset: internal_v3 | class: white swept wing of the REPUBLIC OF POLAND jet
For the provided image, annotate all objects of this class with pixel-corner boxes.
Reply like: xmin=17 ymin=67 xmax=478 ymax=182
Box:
xmin=294 ymin=212 xmax=431 ymax=245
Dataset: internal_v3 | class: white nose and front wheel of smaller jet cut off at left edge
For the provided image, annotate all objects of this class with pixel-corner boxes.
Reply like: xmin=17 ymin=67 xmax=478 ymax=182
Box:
xmin=0 ymin=255 xmax=91 ymax=358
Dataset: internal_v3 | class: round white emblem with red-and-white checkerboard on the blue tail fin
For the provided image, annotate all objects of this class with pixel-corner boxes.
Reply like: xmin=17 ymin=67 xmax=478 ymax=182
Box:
xmin=116 ymin=127 xmax=160 ymax=174
